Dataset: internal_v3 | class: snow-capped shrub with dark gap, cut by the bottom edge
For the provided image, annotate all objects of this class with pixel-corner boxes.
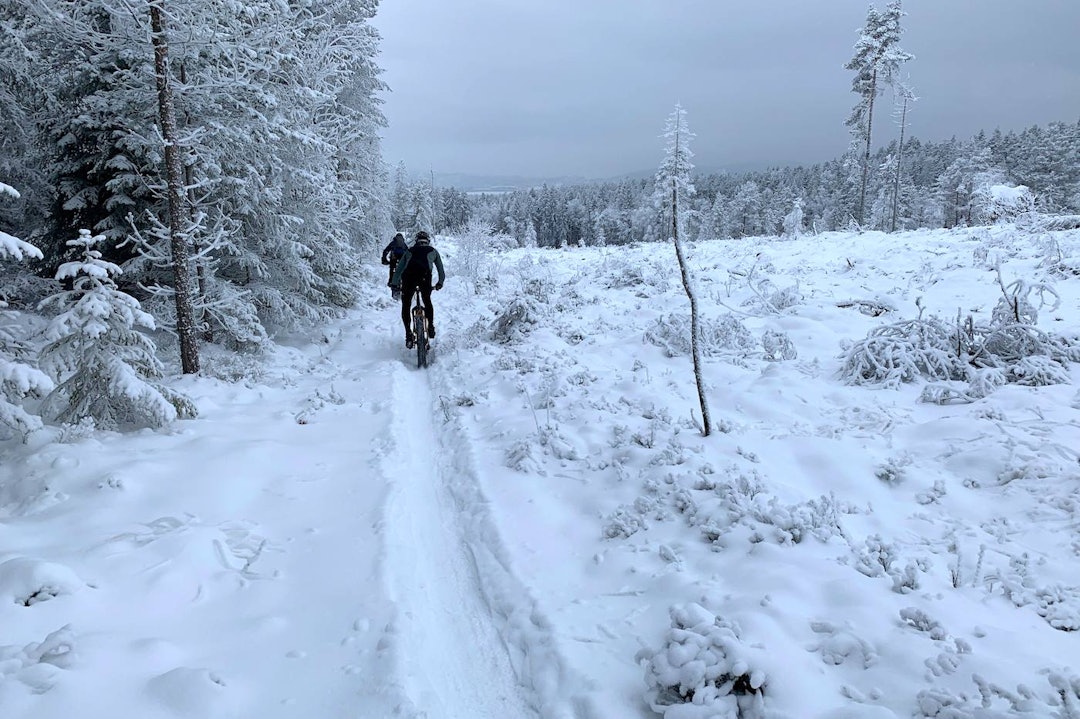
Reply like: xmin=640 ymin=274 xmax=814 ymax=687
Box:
xmin=636 ymin=602 xmax=768 ymax=719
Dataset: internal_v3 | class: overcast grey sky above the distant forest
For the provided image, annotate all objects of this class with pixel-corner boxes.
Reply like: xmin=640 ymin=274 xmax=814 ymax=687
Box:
xmin=375 ymin=0 xmax=1080 ymax=178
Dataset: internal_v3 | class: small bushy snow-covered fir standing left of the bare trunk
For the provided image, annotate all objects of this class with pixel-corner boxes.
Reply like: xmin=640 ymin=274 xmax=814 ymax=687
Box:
xmin=41 ymin=230 xmax=195 ymax=430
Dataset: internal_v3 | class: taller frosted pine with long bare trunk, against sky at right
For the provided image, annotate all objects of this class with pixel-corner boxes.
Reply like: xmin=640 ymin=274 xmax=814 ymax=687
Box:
xmin=845 ymin=0 xmax=912 ymax=225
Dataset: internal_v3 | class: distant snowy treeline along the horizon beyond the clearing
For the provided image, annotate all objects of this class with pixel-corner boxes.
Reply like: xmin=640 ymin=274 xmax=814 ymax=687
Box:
xmin=434 ymin=121 xmax=1080 ymax=247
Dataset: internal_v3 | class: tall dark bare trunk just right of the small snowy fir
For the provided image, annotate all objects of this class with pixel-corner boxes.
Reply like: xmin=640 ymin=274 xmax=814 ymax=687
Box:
xmin=149 ymin=0 xmax=199 ymax=375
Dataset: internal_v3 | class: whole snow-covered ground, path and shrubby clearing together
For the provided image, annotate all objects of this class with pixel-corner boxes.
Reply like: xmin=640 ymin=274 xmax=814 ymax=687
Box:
xmin=0 ymin=227 xmax=1080 ymax=719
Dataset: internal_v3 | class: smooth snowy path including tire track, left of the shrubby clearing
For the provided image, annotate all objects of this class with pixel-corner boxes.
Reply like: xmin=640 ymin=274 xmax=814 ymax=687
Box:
xmin=0 ymin=316 xmax=555 ymax=719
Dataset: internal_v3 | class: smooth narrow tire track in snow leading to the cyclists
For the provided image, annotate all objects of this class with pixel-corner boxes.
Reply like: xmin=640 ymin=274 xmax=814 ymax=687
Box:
xmin=383 ymin=366 xmax=540 ymax=719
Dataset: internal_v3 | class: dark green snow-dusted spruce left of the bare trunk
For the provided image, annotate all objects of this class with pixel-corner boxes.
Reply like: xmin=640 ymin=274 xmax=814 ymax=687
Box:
xmin=12 ymin=0 xmax=161 ymax=269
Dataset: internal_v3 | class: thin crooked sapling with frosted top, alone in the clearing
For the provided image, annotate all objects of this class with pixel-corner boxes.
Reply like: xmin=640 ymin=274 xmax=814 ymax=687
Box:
xmin=654 ymin=105 xmax=713 ymax=437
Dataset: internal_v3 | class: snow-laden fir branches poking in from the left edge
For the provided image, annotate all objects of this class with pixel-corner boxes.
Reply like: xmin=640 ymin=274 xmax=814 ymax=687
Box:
xmin=0 ymin=182 xmax=53 ymax=437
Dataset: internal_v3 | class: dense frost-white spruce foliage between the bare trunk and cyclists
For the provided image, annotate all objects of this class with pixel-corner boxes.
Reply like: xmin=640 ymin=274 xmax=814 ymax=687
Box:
xmin=171 ymin=0 xmax=384 ymax=334
